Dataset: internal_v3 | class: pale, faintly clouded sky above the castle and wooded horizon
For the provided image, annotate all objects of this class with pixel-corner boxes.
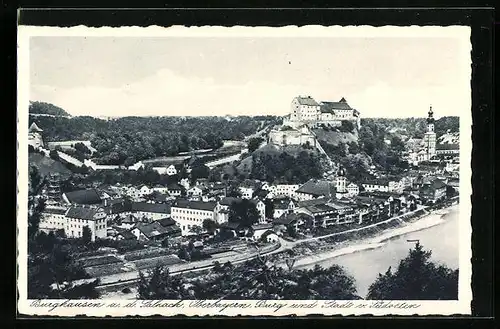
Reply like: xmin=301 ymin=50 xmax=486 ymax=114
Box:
xmin=29 ymin=36 xmax=471 ymax=117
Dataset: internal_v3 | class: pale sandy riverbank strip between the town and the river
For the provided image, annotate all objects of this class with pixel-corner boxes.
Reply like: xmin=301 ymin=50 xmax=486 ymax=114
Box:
xmin=278 ymin=205 xmax=458 ymax=268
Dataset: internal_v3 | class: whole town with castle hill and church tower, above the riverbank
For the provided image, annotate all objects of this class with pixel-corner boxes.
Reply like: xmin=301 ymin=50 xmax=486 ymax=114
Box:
xmin=28 ymin=96 xmax=460 ymax=298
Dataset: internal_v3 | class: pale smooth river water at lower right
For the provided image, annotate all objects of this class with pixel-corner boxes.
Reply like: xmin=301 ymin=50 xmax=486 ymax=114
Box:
xmin=304 ymin=208 xmax=459 ymax=297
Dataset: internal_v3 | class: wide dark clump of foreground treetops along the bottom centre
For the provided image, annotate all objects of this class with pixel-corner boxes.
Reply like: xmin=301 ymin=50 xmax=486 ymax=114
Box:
xmin=138 ymin=256 xmax=359 ymax=300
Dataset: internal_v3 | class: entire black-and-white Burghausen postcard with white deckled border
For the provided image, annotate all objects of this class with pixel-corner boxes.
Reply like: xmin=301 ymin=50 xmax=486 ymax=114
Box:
xmin=17 ymin=26 xmax=472 ymax=316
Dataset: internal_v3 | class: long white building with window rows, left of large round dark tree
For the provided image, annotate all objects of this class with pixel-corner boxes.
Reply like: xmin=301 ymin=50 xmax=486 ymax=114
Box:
xmin=171 ymin=200 xmax=216 ymax=236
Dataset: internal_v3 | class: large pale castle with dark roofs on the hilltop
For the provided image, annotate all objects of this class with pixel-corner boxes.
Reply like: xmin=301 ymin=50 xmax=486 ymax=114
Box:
xmin=283 ymin=96 xmax=361 ymax=129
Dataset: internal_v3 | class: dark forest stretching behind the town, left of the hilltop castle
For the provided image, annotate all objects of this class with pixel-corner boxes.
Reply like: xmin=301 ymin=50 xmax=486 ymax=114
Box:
xmin=30 ymin=102 xmax=277 ymax=165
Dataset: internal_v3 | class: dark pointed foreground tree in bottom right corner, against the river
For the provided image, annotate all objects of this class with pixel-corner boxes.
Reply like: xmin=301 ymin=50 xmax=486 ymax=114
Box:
xmin=367 ymin=243 xmax=458 ymax=300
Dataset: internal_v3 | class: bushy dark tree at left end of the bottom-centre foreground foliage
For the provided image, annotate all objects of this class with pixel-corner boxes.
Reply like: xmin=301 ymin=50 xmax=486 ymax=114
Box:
xmin=137 ymin=265 xmax=189 ymax=300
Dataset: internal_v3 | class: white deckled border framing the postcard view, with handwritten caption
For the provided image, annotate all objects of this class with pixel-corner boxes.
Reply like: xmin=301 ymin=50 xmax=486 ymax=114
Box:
xmin=17 ymin=25 xmax=472 ymax=316
